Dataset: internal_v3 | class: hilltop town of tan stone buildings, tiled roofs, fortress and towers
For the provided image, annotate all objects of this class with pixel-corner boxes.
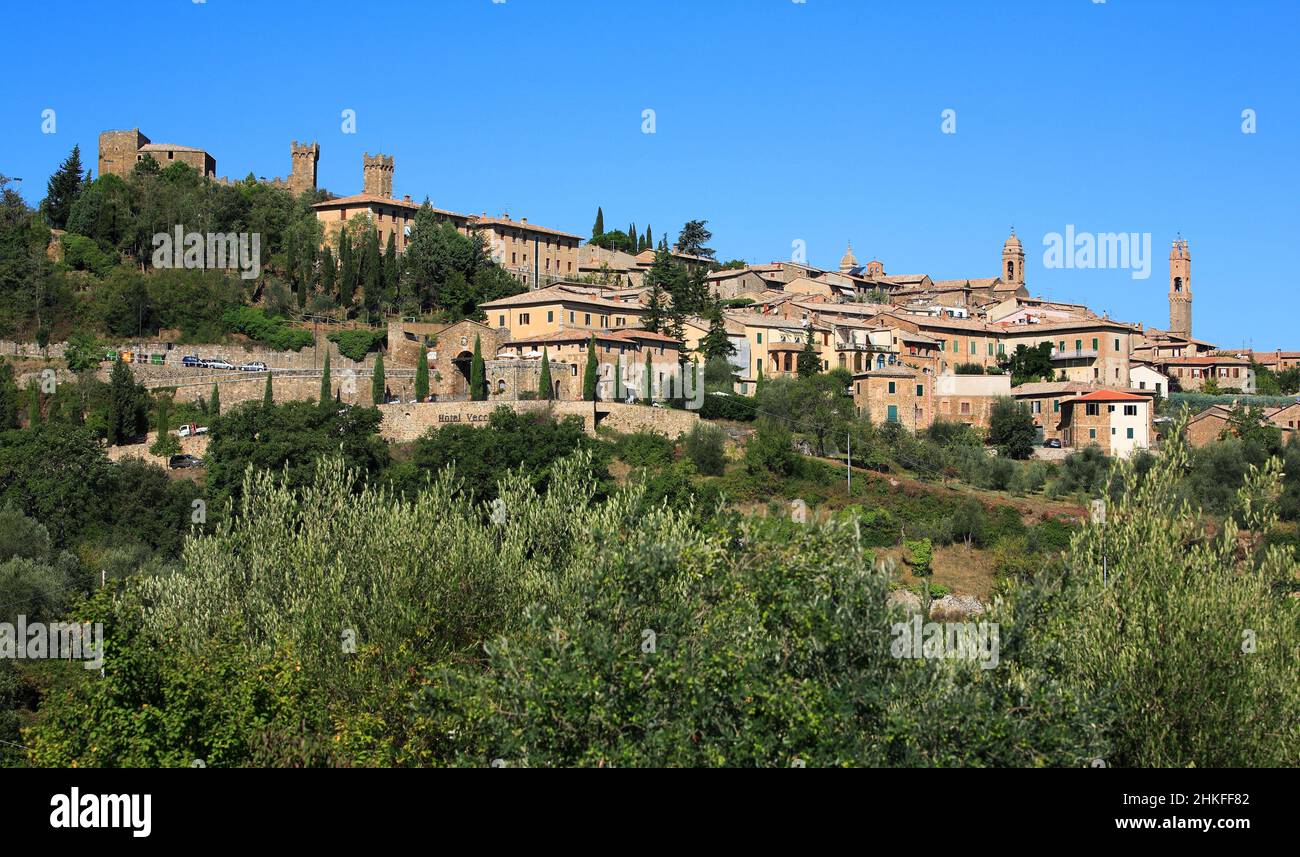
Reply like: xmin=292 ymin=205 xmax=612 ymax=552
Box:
xmin=12 ymin=129 xmax=1300 ymax=456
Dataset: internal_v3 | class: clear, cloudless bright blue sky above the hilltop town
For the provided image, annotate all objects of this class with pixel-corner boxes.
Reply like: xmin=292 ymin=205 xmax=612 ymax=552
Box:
xmin=0 ymin=0 xmax=1300 ymax=349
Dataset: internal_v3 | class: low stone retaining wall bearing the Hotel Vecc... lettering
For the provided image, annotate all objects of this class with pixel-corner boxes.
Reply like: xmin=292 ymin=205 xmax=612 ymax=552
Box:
xmin=377 ymin=399 xmax=699 ymax=442
